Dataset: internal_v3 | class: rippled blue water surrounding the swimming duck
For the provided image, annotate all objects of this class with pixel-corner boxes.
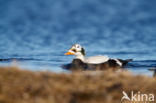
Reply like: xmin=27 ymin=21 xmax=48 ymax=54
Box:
xmin=0 ymin=0 xmax=156 ymax=75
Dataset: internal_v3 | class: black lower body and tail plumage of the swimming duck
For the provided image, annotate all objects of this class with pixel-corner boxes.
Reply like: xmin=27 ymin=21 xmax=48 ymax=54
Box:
xmin=63 ymin=59 xmax=132 ymax=71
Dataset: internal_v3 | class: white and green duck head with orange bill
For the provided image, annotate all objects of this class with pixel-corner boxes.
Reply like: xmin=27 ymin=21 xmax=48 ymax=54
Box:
xmin=65 ymin=44 xmax=85 ymax=61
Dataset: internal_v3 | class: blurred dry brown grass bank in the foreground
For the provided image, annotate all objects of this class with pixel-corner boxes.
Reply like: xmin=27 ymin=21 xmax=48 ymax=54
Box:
xmin=0 ymin=67 xmax=156 ymax=103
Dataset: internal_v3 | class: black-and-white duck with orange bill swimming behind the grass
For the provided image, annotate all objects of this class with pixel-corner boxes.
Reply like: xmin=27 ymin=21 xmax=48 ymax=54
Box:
xmin=63 ymin=44 xmax=132 ymax=70
